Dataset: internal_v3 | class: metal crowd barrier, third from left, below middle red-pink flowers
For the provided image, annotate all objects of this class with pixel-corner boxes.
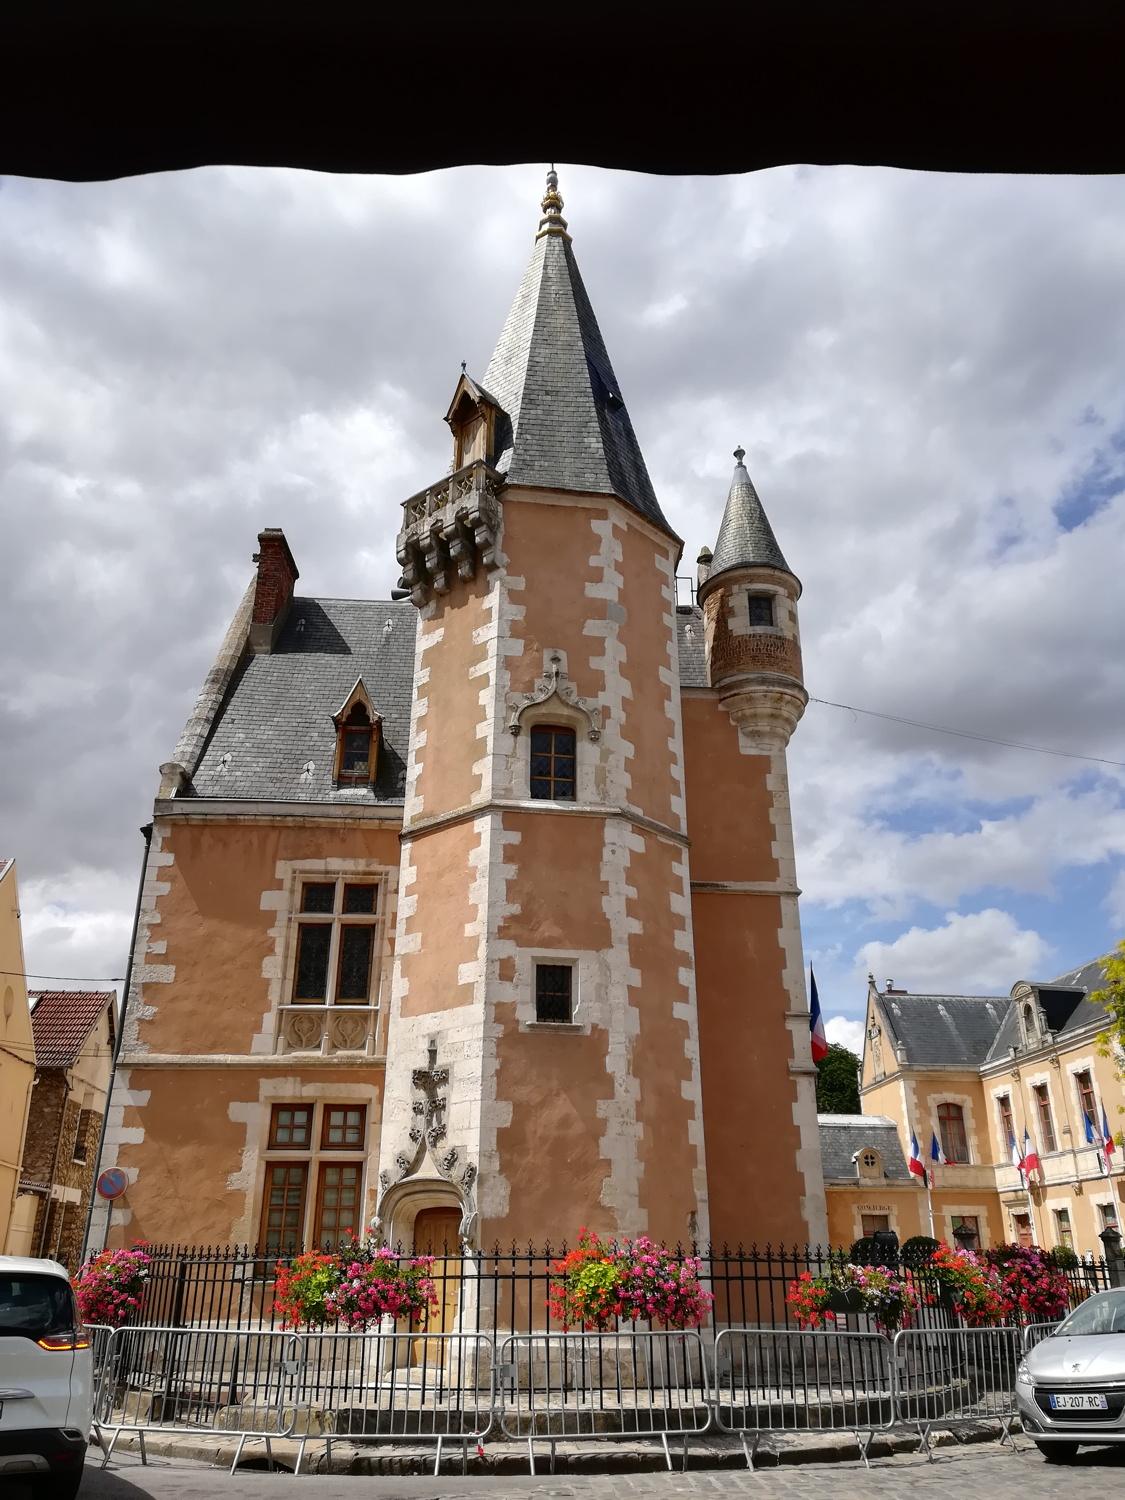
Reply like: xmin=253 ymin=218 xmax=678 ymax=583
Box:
xmin=500 ymin=1329 xmax=711 ymax=1475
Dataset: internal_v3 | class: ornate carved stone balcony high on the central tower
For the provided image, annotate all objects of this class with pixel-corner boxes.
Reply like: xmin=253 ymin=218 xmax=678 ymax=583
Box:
xmin=396 ymin=459 xmax=504 ymax=608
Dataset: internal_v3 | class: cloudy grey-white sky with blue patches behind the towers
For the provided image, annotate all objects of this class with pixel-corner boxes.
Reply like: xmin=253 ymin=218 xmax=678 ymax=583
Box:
xmin=0 ymin=158 xmax=1125 ymax=1038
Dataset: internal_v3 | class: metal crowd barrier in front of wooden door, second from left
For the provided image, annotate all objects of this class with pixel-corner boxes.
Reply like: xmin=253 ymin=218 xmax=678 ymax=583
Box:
xmin=294 ymin=1332 xmax=495 ymax=1475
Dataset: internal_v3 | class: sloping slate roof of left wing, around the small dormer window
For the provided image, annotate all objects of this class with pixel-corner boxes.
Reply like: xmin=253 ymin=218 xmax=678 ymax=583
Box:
xmin=192 ymin=599 xmax=417 ymax=806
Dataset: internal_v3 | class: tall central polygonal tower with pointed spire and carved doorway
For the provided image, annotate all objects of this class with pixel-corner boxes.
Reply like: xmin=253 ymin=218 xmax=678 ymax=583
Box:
xmin=378 ymin=171 xmax=708 ymax=1245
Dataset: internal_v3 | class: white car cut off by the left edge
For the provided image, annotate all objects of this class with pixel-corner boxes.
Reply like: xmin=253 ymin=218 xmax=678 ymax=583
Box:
xmin=0 ymin=1256 xmax=93 ymax=1500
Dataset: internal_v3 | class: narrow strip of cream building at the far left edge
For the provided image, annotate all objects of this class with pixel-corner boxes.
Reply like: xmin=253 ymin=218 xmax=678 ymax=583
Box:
xmin=0 ymin=860 xmax=35 ymax=1254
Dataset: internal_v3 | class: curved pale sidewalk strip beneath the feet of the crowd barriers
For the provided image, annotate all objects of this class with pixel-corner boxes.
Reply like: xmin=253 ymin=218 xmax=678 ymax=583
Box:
xmin=99 ymin=1422 xmax=1001 ymax=1478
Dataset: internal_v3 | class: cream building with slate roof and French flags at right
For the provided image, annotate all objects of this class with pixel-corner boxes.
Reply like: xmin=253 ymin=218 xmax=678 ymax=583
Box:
xmin=846 ymin=960 xmax=1125 ymax=1256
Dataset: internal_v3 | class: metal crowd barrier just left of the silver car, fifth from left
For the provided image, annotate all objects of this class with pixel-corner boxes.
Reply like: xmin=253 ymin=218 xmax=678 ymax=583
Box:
xmin=894 ymin=1328 xmax=1022 ymax=1457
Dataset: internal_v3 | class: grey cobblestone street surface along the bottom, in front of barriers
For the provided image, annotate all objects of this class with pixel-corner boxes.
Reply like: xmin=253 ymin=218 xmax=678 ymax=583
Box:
xmin=63 ymin=1442 xmax=1125 ymax=1500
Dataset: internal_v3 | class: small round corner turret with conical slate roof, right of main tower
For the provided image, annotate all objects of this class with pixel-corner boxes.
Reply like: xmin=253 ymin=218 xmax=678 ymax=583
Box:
xmin=698 ymin=449 xmax=809 ymax=755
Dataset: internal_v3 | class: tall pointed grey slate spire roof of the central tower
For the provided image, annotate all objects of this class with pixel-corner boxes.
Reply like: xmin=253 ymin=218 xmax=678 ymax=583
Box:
xmin=483 ymin=208 xmax=674 ymax=536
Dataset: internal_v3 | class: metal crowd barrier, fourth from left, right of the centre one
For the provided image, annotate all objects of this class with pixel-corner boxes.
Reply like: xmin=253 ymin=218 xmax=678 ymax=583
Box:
xmin=714 ymin=1328 xmax=896 ymax=1469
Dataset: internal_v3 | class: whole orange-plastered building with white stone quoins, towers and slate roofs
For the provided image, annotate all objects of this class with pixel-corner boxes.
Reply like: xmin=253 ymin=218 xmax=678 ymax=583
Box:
xmin=93 ymin=173 xmax=827 ymax=1253
